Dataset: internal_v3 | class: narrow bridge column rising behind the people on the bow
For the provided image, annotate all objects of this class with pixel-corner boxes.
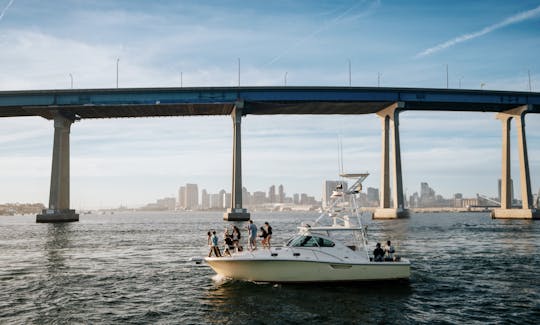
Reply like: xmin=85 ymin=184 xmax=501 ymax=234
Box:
xmin=223 ymin=102 xmax=250 ymax=221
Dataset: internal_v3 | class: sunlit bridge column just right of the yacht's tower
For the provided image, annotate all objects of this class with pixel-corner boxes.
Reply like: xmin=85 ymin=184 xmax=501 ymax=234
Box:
xmin=373 ymin=102 xmax=409 ymax=219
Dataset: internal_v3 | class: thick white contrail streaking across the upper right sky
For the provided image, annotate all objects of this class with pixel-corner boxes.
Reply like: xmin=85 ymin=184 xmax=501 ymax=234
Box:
xmin=415 ymin=6 xmax=540 ymax=58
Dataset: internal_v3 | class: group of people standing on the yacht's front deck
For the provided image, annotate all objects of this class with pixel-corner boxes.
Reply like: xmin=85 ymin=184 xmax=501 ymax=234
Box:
xmin=208 ymin=220 xmax=272 ymax=257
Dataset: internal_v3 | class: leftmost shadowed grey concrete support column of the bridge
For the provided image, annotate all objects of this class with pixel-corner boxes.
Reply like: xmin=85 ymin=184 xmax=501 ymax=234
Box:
xmin=36 ymin=113 xmax=79 ymax=222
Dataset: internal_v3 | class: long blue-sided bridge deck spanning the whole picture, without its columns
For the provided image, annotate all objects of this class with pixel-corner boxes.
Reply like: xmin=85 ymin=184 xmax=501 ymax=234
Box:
xmin=0 ymin=87 xmax=540 ymax=119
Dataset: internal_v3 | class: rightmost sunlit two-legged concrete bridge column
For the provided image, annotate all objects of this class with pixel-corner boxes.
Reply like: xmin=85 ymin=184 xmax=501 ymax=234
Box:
xmin=491 ymin=105 xmax=540 ymax=219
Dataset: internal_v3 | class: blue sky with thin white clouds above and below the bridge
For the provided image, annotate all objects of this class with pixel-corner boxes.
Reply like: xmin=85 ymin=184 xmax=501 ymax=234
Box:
xmin=0 ymin=0 xmax=540 ymax=209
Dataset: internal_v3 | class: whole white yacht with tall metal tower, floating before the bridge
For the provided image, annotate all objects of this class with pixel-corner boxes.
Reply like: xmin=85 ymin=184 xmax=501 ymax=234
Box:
xmin=205 ymin=173 xmax=410 ymax=283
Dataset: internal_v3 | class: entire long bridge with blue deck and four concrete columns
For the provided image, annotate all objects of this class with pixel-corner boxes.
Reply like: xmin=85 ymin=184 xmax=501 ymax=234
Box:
xmin=0 ymin=87 xmax=540 ymax=222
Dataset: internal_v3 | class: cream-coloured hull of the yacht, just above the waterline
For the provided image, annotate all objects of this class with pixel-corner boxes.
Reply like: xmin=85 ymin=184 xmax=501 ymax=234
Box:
xmin=206 ymin=257 xmax=410 ymax=283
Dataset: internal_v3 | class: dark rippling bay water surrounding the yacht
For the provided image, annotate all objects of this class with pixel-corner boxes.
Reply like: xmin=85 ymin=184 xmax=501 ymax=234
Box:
xmin=0 ymin=213 xmax=540 ymax=324
